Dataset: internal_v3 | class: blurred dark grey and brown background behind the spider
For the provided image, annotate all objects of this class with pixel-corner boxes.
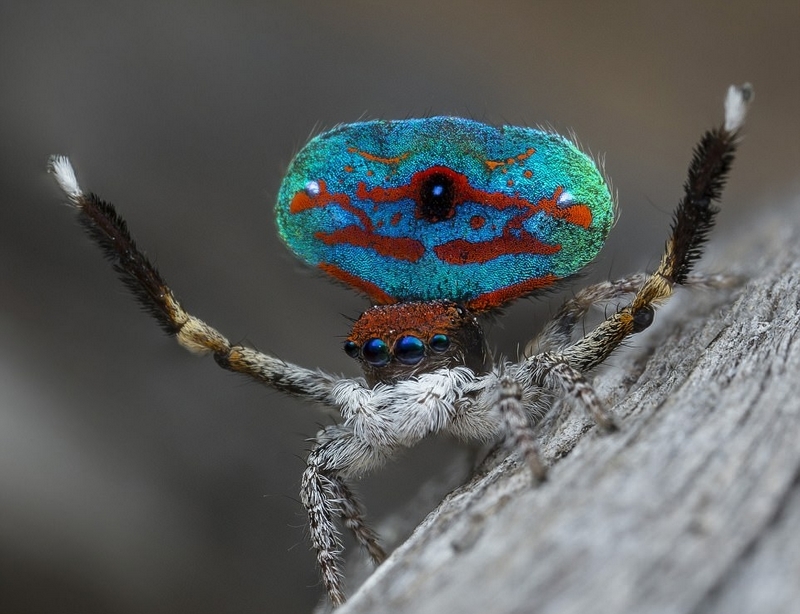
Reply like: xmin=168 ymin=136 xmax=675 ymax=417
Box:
xmin=0 ymin=0 xmax=800 ymax=613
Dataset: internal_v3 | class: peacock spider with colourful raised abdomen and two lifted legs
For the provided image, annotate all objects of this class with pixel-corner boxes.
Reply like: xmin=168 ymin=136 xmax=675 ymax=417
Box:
xmin=49 ymin=85 xmax=752 ymax=605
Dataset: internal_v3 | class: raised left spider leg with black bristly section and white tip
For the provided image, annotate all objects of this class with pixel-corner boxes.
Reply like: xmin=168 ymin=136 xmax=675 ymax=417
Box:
xmin=49 ymin=156 xmax=346 ymax=406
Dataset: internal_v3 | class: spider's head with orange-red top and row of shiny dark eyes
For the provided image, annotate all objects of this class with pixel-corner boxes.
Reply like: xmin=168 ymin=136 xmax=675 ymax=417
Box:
xmin=344 ymin=301 xmax=486 ymax=386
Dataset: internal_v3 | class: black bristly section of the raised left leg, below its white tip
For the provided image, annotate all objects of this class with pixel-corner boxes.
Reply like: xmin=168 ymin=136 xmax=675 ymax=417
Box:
xmin=73 ymin=193 xmax=180 ymax=335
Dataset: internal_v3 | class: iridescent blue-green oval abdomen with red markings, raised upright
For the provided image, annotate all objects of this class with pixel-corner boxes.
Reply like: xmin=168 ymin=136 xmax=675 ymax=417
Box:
xmin=276 ymin=117 xmax=614 ymax=311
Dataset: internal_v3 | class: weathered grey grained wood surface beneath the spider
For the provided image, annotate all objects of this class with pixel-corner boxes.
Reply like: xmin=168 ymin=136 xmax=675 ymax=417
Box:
xmin=339 ymin=205 xmax=800 ymax=614
